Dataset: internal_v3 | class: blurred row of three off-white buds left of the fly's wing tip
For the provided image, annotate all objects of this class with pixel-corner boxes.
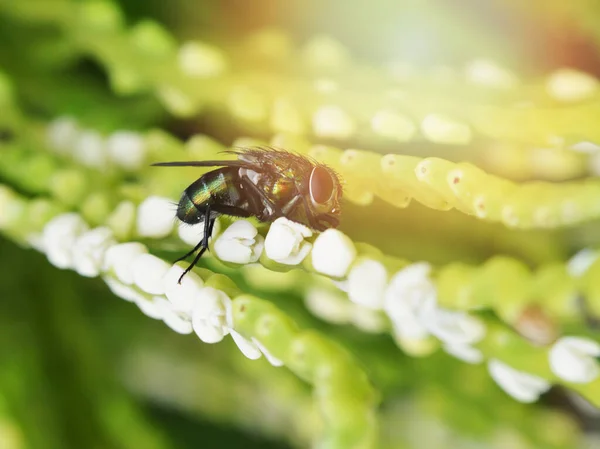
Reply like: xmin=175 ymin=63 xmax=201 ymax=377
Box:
xmin=47 ymin=117 xmax=147 ymax=170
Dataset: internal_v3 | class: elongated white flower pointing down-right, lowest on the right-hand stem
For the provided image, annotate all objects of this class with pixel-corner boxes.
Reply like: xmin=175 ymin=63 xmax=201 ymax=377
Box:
xmin=488 ymin=359 xmax=550 ymax=403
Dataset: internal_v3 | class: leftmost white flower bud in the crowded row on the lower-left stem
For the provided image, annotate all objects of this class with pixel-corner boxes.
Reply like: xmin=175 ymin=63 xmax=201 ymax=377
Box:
xmin=42 ymin=213 xmax=89 ymax=269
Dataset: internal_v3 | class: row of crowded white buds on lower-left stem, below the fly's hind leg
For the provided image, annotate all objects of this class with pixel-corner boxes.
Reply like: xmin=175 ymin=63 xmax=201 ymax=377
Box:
xmin=40 ymin=210 xmax=282 ymax=366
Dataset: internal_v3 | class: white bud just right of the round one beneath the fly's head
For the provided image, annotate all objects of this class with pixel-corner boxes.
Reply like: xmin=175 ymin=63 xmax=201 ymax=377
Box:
xmin=348 ymin=259 xmax=387 ymax=310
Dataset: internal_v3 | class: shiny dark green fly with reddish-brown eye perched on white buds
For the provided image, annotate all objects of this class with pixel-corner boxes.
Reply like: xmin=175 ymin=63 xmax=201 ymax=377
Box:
xmin=153 ymin=147 xmax=342 ymax=283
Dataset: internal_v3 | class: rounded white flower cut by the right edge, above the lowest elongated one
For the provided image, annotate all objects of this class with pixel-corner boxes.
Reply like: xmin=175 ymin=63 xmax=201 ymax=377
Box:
xmin=549 ymin=337 xmax=600 ymax=383
